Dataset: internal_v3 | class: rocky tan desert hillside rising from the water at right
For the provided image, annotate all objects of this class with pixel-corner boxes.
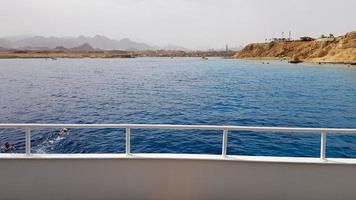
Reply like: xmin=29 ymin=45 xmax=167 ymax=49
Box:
xmin=234 ymin=31 xmax=356 ymax=64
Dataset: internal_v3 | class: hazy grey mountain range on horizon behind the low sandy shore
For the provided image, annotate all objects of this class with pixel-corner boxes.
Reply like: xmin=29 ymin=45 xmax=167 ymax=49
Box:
xmin=0 ymin=35 xmax=186 ymax=50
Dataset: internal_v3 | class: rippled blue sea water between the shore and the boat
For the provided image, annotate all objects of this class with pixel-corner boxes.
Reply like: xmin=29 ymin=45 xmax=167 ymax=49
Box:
xmin=0 ymin=58 xmax=356 ymax=158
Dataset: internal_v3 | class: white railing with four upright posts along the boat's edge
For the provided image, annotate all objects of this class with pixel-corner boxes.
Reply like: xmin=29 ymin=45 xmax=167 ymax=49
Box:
xmin=0 ymin=124 xmax=356 ymax=160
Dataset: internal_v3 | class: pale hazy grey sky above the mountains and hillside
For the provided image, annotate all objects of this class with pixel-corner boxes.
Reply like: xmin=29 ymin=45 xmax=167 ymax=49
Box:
xmin=0 ymin=0 xmax=356 ymax=49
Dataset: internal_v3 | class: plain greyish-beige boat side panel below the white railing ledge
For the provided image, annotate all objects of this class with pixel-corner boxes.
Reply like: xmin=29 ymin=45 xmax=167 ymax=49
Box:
xmin=0 ymin=158 xmax=356 ymax=200
